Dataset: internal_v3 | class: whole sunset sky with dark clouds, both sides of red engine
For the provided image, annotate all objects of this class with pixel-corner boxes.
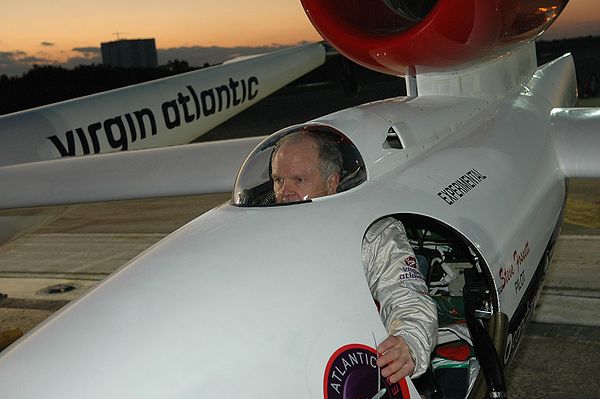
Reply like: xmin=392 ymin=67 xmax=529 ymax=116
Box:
xmin=0 ymin=0 xmax=600 ymax=75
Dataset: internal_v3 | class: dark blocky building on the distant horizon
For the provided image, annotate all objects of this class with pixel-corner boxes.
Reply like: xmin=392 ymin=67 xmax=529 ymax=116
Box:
xmin=102 ymin=39 xmax=158 ymax=68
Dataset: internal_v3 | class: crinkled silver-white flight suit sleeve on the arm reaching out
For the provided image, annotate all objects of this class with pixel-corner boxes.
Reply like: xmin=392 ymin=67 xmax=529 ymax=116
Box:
xmin=362 ymin=217 xmax=438 ymax=377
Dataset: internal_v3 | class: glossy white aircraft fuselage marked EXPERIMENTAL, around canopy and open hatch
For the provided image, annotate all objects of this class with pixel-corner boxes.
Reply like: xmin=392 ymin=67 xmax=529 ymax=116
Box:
xmin=0 ymin=45 xmax=573 ymax=399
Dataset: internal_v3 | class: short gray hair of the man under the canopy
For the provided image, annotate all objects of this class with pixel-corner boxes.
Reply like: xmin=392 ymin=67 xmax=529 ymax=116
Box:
xmin=271 ymin=130 xmax=344 ymax=179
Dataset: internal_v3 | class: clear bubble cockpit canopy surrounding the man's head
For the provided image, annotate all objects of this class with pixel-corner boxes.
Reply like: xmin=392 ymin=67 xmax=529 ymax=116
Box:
xmin=232 ymin=124 xmax=367 ymax=207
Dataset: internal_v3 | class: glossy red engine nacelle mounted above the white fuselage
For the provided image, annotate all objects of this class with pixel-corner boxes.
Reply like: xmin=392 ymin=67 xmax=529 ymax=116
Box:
xmin=301 ymin=0 xmax=568 ymax=75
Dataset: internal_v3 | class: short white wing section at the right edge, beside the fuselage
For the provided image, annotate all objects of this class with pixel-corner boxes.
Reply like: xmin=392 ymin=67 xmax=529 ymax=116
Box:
xmin=551 ymin=108 xmax=600 ymax=177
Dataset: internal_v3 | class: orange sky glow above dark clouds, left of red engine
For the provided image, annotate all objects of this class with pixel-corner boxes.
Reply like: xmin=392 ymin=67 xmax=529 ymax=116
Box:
xmin=0 ymin=0 xmax=321 ymax=62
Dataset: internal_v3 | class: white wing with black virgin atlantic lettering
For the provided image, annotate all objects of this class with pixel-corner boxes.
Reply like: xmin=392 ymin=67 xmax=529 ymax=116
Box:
xmin=0 ymin=43 xmax=325 ymax=166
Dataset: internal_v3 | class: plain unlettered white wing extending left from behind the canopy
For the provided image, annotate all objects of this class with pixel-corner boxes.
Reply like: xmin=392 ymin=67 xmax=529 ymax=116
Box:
xmin=0 ymin=137 xmax=264 ymax=209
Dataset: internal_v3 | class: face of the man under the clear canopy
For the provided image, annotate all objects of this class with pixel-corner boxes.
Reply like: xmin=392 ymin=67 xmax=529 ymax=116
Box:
xmin=272 ymin=138 xmax=337 ymax=203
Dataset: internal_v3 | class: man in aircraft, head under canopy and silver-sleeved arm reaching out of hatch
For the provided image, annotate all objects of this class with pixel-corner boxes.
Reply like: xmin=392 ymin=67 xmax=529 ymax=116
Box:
xmin=271 ymin=131 xmax=437 ymax=383
